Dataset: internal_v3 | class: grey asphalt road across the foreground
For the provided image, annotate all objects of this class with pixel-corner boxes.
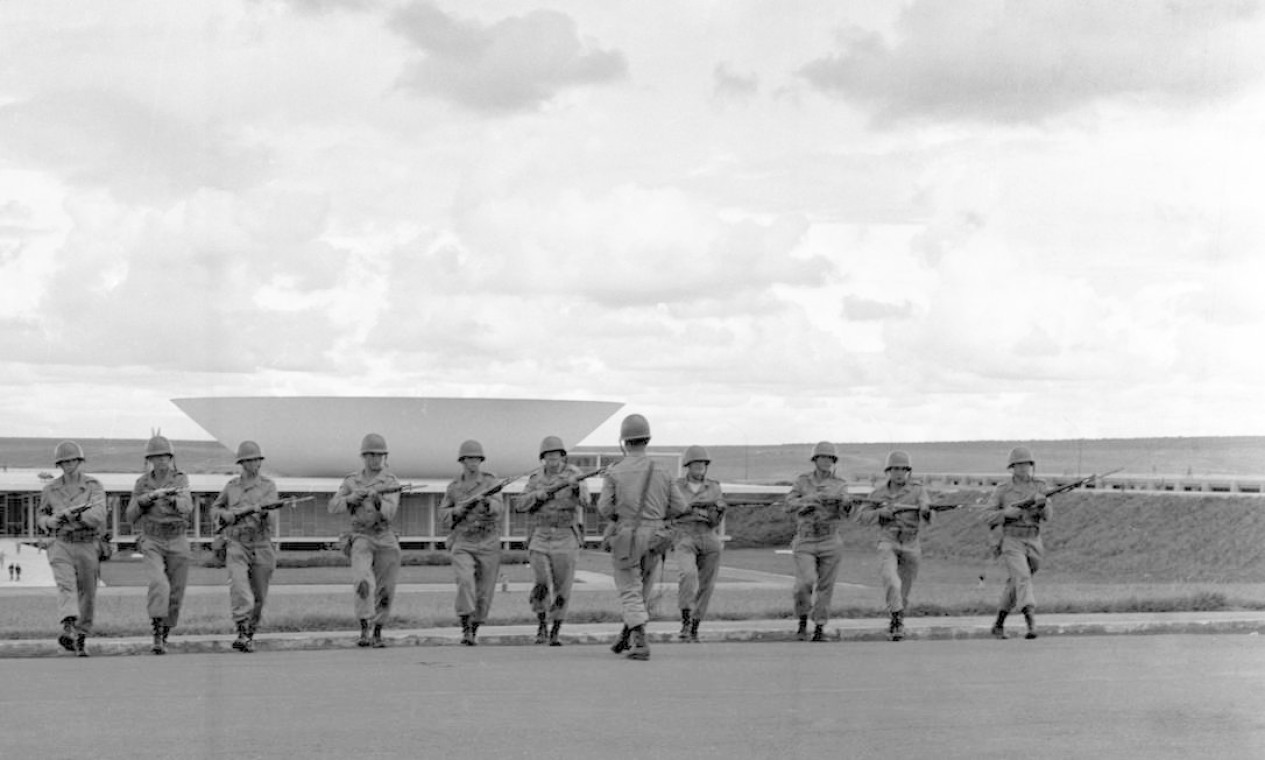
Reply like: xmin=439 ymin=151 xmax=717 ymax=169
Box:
xmin=9 ymin=635 xmax=1265 ymax=760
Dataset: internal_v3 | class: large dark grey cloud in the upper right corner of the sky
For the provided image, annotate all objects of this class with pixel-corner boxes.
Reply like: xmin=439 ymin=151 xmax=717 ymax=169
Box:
xmin=799 ymin=0 xmax=1259 ymax=123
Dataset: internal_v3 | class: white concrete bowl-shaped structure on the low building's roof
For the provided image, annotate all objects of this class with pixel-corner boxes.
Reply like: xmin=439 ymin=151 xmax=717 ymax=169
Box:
xmin=172 ymin=396 xmax=624 ymax=478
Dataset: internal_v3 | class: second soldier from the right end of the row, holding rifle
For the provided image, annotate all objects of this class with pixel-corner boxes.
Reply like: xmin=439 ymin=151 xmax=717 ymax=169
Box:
xmin=856 ymin=450 xmax=931 ymax=641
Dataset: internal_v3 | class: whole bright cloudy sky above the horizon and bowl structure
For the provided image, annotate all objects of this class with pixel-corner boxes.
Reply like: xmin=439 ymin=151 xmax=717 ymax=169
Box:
xmin=0 ymin=0 xmax=1265 ymax=444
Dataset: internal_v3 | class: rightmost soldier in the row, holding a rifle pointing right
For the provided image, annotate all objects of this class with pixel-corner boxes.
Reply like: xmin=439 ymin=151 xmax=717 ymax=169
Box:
xmin=984 ymin=446 xmax=1050 ymax=639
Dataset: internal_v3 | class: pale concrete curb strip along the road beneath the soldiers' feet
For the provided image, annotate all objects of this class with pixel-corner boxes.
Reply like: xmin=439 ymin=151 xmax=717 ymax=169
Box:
xmin=7 ymin=612 xmax=1265 ymax=659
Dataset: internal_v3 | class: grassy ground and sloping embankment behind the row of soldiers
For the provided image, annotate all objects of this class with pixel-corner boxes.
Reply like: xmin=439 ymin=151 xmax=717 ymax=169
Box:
xmin=0 ymin=492 xmax=1265 ymax=639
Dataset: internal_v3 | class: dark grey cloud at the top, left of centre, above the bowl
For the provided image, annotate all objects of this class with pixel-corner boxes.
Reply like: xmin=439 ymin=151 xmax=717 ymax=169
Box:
xmin=390 ymin=3 xmax=627 ymax=114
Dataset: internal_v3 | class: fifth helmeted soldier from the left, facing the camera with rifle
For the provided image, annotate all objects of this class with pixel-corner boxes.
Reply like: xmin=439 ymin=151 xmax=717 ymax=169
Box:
xmin=439 ymin=440 xmax=505 ymax=646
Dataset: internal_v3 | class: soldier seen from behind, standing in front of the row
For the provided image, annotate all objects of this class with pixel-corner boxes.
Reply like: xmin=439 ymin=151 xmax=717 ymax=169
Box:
xmin=597 ymin=415 xmax=688 ymax=660
